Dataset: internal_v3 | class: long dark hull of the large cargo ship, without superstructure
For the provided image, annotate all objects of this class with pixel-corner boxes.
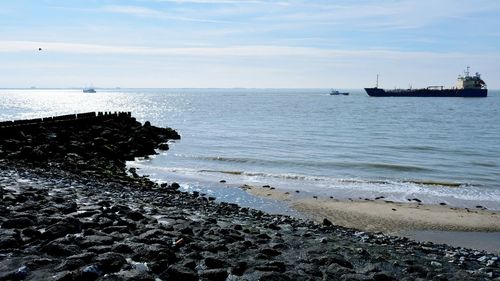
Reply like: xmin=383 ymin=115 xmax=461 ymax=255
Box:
xmin=365 ymin=88 xmax=488 ymax=98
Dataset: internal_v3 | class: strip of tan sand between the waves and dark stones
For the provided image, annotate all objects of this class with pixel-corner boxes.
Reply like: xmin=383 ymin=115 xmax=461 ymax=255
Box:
xmin=248 ymin=187 xmax=500 ymax=234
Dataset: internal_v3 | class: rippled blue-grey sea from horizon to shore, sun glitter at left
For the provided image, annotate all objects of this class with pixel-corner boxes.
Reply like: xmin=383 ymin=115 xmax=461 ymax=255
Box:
xmin=0 ymin=89 xmax=500 ymax=210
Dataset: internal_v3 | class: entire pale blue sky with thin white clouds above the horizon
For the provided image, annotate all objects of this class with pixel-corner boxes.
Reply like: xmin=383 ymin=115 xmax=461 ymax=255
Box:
xmin=0 ymin=0 xmax=500 ymax=89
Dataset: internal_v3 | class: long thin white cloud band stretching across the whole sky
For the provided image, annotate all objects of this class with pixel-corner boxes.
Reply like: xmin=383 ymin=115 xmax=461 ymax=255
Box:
xmin=0 ymin=41 xmax=500 ymax=59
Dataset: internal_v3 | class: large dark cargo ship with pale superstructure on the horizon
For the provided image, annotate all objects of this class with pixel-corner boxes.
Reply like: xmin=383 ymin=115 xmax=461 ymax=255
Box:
xmin=365 ymin=67 xmax=488 ymax=98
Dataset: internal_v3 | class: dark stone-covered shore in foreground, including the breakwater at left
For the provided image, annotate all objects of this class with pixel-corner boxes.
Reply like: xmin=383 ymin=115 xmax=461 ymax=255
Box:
xmin=0 ymin=113 xmax=500 ymax=281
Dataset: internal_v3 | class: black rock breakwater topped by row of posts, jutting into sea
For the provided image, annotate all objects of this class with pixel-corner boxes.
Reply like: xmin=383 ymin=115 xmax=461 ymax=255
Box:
xmin=0 ymin=112 xmax=180 ymax=185
